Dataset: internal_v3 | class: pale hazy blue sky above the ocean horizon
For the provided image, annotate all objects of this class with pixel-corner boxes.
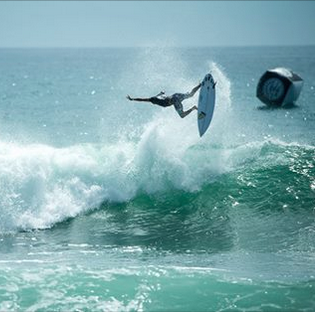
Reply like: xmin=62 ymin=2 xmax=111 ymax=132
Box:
xmin=0 ymin=1 xmax=315 ymax=47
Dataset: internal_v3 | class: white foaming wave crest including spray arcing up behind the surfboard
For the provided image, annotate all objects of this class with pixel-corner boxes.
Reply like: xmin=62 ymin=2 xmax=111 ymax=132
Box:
xmin=0 ymin=56 xmax=315 ymax=233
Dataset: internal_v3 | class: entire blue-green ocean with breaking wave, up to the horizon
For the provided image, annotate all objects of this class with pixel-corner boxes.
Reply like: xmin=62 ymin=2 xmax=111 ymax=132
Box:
xmin=0 ymin=46 xmax=315 ymax=311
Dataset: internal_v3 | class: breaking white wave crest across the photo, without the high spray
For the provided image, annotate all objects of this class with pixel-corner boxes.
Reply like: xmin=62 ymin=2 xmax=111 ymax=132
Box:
xmin=0 ymin=134 xmax=315 ymax=232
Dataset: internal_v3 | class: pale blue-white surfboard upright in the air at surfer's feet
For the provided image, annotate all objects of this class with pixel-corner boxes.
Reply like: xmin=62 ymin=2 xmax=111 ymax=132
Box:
xmin=198 ymin=74 xmax=216 ymax=137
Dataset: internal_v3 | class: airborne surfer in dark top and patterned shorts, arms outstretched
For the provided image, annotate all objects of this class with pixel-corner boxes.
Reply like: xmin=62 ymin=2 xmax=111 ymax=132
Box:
xmin=127 ymin=83 xmax=201 ymax=118
